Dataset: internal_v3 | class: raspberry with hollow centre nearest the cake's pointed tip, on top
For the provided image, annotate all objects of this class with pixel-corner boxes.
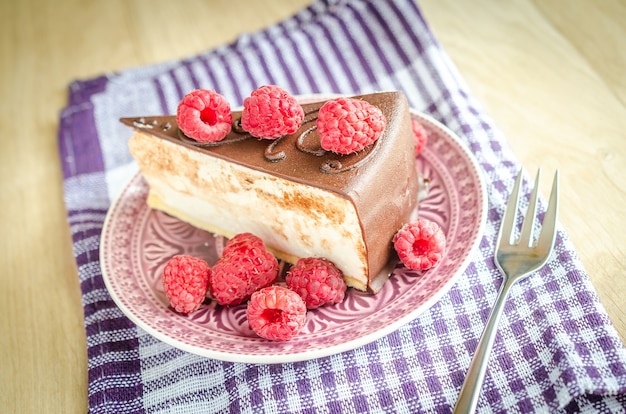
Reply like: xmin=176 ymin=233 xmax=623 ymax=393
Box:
xmin=176 ymin=89 xmax=233 ymax=142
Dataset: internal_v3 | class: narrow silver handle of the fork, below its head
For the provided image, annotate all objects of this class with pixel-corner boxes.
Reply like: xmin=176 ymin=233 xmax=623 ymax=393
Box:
xmin=454 ymin=277 xmax=517 ymax=414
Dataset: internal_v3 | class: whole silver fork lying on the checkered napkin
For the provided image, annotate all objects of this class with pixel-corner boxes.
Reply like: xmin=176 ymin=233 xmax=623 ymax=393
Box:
xmin=454 ymin=170 xmax=559 ymax=413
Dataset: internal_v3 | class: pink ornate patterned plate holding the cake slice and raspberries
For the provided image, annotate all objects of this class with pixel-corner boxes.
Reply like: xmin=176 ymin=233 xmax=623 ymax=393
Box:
xmin=100 ymin=108 xmax=487 ymax=363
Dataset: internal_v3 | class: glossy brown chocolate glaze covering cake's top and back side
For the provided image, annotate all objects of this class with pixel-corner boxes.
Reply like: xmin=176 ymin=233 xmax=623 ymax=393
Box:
xmin=121 ymin=92 xmax=418 ymax=292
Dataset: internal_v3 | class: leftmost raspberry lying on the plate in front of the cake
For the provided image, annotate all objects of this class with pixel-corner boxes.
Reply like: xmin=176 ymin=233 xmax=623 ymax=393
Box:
xmin=163 ymin=255 xmax=211 ymax=313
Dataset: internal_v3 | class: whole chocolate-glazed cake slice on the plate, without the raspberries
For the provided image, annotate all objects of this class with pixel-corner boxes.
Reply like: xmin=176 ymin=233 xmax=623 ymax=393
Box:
xmin=122 ymin=92 xmax=418 ymax=293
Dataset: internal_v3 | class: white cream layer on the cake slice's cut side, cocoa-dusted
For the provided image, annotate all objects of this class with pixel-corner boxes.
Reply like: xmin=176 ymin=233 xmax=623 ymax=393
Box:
xmin=129 ymin=132 xmax=368 ymax=290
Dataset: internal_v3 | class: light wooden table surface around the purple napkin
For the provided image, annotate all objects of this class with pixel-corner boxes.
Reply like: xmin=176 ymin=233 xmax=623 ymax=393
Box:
xmin=0 ymin=0 xmax=626 ymax=413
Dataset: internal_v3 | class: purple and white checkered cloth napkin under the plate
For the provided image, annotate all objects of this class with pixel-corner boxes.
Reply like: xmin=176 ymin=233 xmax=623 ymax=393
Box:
xmin=59 ymin=0 xmax=626 ymax=413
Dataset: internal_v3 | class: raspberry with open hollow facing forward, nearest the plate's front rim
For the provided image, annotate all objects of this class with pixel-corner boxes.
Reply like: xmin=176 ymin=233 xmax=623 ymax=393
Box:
xmin=246 ymin=286 xmax=306 ymax=341
